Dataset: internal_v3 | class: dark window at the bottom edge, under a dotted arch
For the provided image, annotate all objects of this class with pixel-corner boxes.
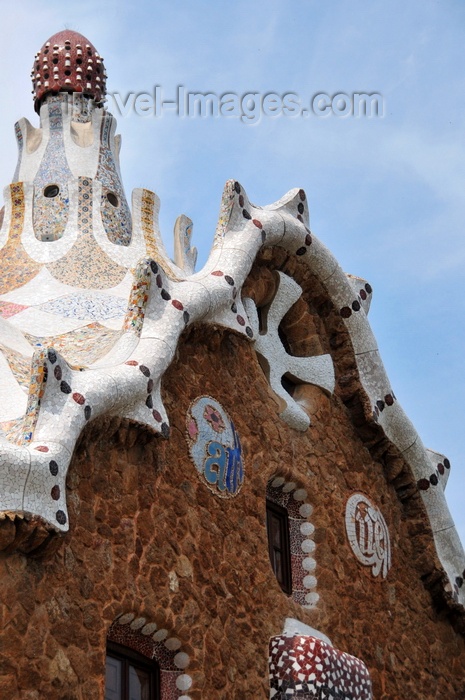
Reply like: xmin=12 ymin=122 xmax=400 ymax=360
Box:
xmin=105 ymin=642 xmax=160 ymax=700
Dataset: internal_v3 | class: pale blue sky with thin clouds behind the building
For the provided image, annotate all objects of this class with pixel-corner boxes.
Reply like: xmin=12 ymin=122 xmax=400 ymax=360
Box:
xmin=0 ymin=0 xmax=465 ymax=542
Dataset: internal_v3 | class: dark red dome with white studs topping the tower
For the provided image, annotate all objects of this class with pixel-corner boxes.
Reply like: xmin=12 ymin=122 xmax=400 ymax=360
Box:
xmin=31 ymin=29 xmax=106 ymax=113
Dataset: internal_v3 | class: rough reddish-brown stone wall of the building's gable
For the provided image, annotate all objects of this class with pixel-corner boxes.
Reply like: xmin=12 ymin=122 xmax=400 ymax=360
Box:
xmin=0 ymin=266 xmax=465 ymax=700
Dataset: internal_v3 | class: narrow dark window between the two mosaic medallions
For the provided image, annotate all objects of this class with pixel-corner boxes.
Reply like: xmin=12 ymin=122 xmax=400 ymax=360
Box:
xmin=266 ymin=500 xmax=292 ymax=595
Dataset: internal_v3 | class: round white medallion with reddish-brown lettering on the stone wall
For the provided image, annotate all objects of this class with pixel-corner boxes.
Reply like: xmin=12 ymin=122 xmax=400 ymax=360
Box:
xmin=346 ymin=493 xmax=391 ymax=578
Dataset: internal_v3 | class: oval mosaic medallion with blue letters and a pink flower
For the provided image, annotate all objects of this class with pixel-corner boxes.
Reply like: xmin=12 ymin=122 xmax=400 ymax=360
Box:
xmin=187 ymin=396 xmax=244 ymax=498
